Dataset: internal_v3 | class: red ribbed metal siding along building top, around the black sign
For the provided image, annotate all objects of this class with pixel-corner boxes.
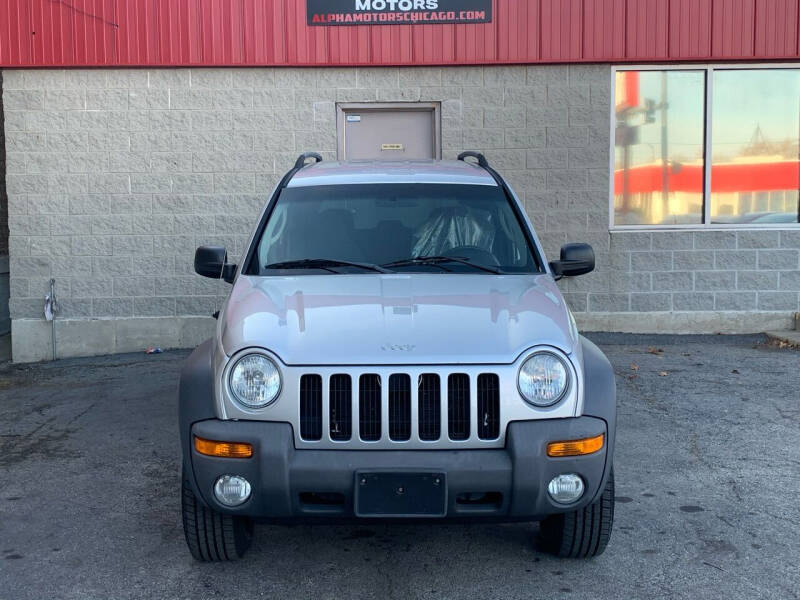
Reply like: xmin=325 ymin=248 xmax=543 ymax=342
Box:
xmin=0 ymin=0 xmax=800 ymax=67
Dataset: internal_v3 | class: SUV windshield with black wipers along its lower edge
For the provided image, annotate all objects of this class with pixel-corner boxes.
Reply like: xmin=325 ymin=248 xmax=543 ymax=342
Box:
xmin=248 ymin=184 xmax=538 ymax=275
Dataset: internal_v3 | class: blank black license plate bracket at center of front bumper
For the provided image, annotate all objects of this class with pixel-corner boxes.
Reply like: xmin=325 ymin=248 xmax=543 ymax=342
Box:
xmin=354 ymin=471 xmax=447 ymax=518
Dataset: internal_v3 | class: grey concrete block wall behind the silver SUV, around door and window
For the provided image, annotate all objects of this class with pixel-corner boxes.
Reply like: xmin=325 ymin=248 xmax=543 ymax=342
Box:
xmin=3 ymin=65 xmax=798 ymax=360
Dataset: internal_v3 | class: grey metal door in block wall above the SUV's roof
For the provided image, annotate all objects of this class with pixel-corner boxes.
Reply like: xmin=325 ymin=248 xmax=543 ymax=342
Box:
xmin=338 ymin=103 xmax=441 ymax=160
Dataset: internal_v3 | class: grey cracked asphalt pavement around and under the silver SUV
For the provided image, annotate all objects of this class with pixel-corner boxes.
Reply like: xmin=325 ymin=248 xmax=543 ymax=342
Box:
xmin=0 ymin=334 xmax=800 ymax=600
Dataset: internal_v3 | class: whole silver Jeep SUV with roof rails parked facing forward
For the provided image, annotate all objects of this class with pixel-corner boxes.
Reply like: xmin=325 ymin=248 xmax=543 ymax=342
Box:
xmin=179 ymin=152 xmax=616 ymax=560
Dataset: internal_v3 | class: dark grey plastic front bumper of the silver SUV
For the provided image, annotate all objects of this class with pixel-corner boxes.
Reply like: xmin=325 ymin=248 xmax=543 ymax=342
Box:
xmin=186 ymin=416 xmax=613 ymax=520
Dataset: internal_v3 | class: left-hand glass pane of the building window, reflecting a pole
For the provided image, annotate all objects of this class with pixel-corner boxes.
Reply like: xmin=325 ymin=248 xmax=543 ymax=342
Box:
xmin=614 ymin=71 xmax=705 ymax=225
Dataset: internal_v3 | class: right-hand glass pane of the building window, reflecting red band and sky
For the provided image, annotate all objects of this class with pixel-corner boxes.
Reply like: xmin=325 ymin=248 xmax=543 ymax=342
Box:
xmin=711 ymin=69 xmax=800 ymax=224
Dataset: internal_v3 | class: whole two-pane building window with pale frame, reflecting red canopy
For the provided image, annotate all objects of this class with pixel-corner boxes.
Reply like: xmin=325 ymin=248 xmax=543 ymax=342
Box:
xmin=612 ymin=67 xmax=800 ymax=227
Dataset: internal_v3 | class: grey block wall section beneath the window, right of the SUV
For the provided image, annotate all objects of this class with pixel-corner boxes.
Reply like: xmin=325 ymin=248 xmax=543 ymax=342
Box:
xmin=564 ymin=228 xmax=800 ymax=333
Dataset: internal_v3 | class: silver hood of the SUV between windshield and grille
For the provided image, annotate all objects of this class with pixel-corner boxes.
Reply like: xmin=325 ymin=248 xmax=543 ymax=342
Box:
xmin=220 ymin=273 xmax=577 ymax=365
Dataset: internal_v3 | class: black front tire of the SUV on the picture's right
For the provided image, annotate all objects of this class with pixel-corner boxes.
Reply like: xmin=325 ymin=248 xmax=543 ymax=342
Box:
xmin=541 ymin=469 xmax=614 ymax=558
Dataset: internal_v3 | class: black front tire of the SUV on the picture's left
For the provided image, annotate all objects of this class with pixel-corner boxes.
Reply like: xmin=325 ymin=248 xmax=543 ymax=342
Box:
xmin=181 ymin=472 xmax=253 ymax=562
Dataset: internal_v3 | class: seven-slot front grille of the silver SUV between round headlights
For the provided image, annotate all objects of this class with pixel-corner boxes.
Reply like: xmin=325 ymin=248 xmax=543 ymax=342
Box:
xmin=299 ymin=373 xmax=500 ymax=442
